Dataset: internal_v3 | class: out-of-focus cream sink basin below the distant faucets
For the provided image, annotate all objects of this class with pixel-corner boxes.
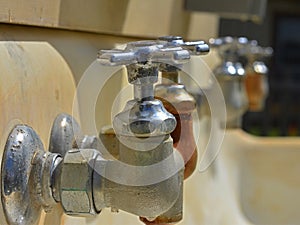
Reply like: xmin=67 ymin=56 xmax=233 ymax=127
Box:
xmin=180 ymin=129 xmax=300 ymax=225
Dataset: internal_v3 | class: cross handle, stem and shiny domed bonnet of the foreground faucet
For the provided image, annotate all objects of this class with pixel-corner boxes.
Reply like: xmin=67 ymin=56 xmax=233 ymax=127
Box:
xmin=98 ymin=40 xmax=205 ymax=136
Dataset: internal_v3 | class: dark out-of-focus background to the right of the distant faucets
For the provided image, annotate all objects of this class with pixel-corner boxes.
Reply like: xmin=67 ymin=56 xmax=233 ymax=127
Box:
xmin=187 ymin=0 xmax=300 ymax=136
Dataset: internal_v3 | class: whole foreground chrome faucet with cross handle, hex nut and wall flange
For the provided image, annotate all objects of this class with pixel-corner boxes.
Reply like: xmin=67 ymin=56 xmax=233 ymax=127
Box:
xmin=1 ymin=40 xmax=200 ymax=225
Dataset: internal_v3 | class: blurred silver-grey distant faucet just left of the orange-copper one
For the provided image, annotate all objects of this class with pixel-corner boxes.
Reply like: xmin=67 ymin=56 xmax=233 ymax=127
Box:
xmin=209 ymin=37 xmax=249 ymax=128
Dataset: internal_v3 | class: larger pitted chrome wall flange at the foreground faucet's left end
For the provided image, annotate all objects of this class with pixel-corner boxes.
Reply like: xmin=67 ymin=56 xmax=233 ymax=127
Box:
xmin=1 ymin=126 xmax=43 ymax=225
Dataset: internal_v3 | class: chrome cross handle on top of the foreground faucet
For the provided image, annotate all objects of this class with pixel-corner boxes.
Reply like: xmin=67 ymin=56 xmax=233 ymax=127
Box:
xmin=98 ymin=40 xmax=190 ymax=66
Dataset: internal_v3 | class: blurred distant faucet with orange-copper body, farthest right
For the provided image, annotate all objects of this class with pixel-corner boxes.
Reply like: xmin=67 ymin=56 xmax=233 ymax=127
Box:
xmin=243 ymin=41 xmax=273 ymax=112
